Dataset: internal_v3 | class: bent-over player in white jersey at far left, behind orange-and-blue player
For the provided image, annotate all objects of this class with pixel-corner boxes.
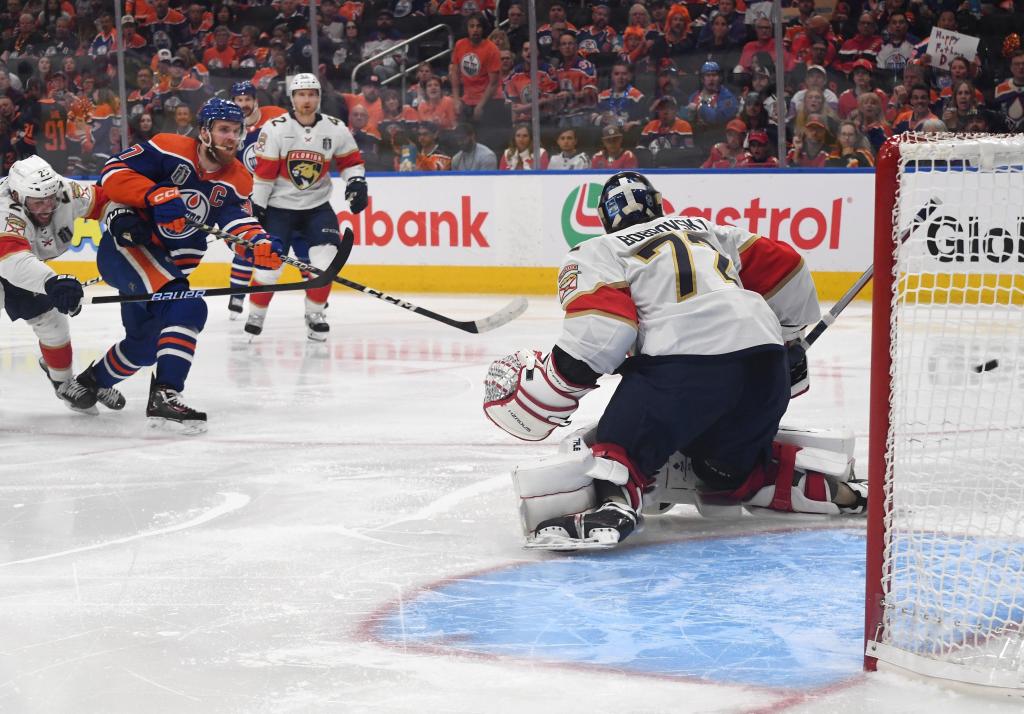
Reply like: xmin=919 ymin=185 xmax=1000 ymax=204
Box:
xmin=0 ymin=156 xmax=125 ymax=414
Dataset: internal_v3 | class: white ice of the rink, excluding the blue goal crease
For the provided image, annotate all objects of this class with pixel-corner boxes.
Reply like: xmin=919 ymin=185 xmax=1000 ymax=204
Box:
xmin=0 ymin=293 xmax=1021 ymax=714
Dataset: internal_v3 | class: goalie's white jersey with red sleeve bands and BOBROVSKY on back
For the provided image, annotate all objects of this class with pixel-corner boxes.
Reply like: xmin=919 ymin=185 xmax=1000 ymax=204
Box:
xmin=558 ymin=216 xmax=820 ymax=374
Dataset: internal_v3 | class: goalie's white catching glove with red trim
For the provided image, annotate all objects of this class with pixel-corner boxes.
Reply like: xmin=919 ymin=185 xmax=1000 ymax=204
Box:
xmin=483 ymin=349 xmax=597 ymax=442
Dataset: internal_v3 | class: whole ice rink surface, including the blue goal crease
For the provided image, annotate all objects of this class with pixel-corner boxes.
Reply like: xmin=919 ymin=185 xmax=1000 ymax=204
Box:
xmin=0 ymin=293 xmax=1024 ymax=714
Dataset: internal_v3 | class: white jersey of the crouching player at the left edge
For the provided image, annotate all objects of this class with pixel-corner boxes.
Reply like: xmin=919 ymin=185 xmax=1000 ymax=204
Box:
xmin=0 ymin=177 xmax=96 ymax=293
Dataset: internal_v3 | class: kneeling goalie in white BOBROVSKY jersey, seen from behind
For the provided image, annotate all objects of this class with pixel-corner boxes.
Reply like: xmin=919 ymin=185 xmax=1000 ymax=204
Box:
xmin=483 ymin=171 xmax=867 ymax=550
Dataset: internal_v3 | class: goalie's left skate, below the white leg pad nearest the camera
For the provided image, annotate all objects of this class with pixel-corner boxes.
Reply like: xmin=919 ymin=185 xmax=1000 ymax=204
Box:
xmin=526 ymin=501 xmax=640 ymax=550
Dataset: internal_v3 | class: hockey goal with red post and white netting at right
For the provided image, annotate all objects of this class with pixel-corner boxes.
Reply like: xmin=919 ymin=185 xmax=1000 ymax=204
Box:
xmin=864 ymin=134 xmax=1024 ymax=694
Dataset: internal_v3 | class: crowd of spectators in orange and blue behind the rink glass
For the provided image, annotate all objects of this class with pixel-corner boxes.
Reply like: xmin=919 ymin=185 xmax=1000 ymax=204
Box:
xmin=0 ymin=0 xmax=1024 ymax=173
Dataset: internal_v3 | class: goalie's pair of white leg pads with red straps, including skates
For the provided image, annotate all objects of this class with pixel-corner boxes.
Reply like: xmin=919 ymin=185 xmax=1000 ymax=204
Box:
xmin=512 ymin=426 xmax=867 ymax=550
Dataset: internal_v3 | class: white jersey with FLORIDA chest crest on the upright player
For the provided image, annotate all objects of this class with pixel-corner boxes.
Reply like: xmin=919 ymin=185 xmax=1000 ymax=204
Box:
xmin=252 ymin=112 xmax=366 ymax=210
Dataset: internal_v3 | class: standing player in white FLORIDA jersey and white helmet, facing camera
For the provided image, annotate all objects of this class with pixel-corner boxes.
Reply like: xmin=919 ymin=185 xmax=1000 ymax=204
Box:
xmin=245 ymin=74 xmax=368 ymax=341
